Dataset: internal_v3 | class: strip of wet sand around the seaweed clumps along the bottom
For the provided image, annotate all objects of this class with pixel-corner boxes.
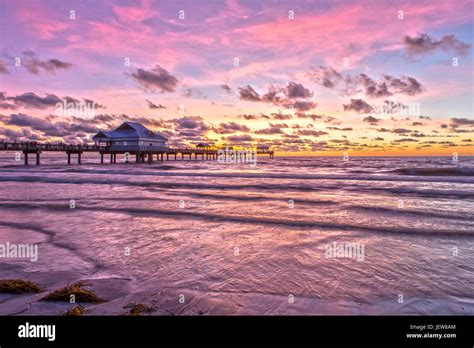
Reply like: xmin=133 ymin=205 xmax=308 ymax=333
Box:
xmin=0 ymin=267 xmax=474 ymax=316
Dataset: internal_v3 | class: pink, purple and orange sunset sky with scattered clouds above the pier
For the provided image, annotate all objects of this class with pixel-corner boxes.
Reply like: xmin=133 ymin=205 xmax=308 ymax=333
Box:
xmin=0 ymin=0 xmax=474 ymax=156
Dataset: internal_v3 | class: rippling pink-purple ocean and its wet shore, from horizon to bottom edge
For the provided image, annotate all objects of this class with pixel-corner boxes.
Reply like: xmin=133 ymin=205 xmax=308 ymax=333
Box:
xmin=0 ymin=154 xmax=474 ymax=315
